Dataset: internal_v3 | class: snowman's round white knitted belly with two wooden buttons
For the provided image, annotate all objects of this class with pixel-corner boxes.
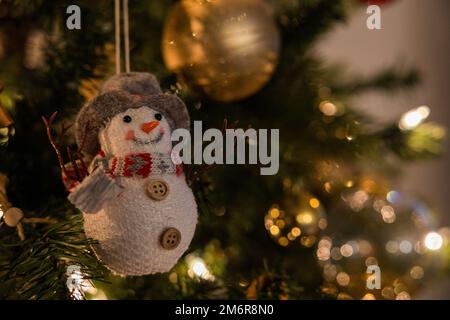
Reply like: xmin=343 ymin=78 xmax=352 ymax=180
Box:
xmin=84 ymin=175 xmax=197 ymax=275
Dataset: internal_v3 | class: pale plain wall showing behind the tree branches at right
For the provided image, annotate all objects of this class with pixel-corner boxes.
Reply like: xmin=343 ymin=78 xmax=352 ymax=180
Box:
xmin=318 ymin=0 xmax=450 ymax=228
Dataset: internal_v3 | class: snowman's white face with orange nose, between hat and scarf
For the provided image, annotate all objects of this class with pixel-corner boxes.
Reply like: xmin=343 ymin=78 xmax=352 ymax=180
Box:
xmin=99 ymin=107 xmax=172 ymax=156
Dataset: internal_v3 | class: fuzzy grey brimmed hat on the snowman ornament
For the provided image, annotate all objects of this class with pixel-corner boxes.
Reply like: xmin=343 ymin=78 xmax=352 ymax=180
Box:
xmin=75 ymin=72 xmax=190 ymax=155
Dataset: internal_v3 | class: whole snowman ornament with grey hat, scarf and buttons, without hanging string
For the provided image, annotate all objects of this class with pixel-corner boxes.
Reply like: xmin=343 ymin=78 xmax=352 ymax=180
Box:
xmin=68 ymin=72 xmax=197 ymax=276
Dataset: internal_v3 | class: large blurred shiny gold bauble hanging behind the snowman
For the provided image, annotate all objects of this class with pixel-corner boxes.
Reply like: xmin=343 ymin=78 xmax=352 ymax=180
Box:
xmin=162 ymin=0 xmax=280 ymax=102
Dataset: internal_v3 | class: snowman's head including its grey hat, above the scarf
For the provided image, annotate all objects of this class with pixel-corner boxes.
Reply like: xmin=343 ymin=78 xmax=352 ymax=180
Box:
xmin=75 ymin=72 xmax=190 ymax=156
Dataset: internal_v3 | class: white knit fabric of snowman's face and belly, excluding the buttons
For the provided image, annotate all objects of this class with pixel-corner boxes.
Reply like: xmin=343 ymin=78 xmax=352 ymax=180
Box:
xmin=84 ymin=107 xmax=197 ymax=276
